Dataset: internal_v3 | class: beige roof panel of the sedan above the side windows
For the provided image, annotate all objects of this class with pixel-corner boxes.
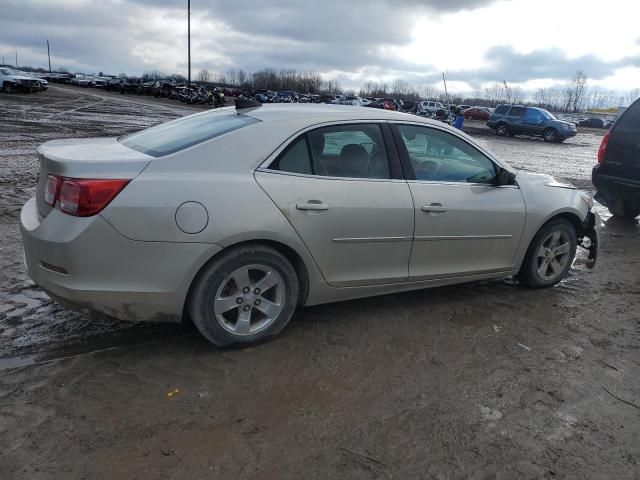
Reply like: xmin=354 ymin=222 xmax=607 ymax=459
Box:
xmin=240 ymin=103 xmax=432 ymax=125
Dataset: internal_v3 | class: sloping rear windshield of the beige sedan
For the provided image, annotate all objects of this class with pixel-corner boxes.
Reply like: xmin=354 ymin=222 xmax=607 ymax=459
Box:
xmin=119 ymin=112 xmax=260 ymax=157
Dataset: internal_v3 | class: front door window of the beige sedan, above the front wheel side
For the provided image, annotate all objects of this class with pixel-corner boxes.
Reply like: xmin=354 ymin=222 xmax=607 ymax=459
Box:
xmin=398 ymin=125 xmax=496 ymax=183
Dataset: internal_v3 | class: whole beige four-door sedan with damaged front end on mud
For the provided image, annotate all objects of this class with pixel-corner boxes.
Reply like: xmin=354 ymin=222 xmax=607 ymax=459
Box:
xmin=21 ymin=100 xmax=597 ymax=346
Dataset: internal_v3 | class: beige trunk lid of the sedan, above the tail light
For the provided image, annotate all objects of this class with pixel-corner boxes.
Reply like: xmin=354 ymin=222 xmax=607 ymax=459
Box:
xmin=36 ymin=138 xmax=153 ymax=217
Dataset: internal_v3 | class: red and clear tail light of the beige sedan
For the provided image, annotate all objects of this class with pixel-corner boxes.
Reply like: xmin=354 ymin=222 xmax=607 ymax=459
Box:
xmin=45 ymin=175 xmax=129 ymax=217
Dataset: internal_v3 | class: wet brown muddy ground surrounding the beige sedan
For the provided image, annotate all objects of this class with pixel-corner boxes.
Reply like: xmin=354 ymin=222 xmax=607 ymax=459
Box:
xmin=0 ymin=87 xmax=640 ymax=480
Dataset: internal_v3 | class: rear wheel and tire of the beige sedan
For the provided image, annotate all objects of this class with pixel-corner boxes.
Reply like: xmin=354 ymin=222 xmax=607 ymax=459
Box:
xmin=188 ymin=245 xmax=299 ymax=347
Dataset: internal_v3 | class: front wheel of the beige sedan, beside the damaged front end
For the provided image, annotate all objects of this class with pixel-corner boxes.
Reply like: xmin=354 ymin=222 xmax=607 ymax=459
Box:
xmin=518 ymin=218 xmax=577 ymax=288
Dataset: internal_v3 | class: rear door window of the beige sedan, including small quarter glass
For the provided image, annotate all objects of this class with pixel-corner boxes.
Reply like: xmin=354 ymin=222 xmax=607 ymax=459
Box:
xmin=269 ymin=124 xmax=391 ymax=179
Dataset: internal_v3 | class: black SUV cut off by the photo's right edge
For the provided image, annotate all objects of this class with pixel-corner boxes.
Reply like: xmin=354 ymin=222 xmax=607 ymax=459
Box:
xmin=591 ymin=98 xmax=640 ymax=218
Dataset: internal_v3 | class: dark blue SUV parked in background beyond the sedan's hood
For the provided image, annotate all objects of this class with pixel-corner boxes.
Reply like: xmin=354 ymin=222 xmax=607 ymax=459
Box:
xmin=487 ymin=105 xmax=577 ymax=142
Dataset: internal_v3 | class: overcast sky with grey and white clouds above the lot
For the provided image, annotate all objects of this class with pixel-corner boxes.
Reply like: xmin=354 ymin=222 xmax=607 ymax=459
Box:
xmin=0 ymin=0 xmax=640 ymax=91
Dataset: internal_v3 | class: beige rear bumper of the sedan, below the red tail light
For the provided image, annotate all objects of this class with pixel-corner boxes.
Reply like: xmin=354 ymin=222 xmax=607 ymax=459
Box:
xmin=20 ymin=198 xmax=221 ymax=321
